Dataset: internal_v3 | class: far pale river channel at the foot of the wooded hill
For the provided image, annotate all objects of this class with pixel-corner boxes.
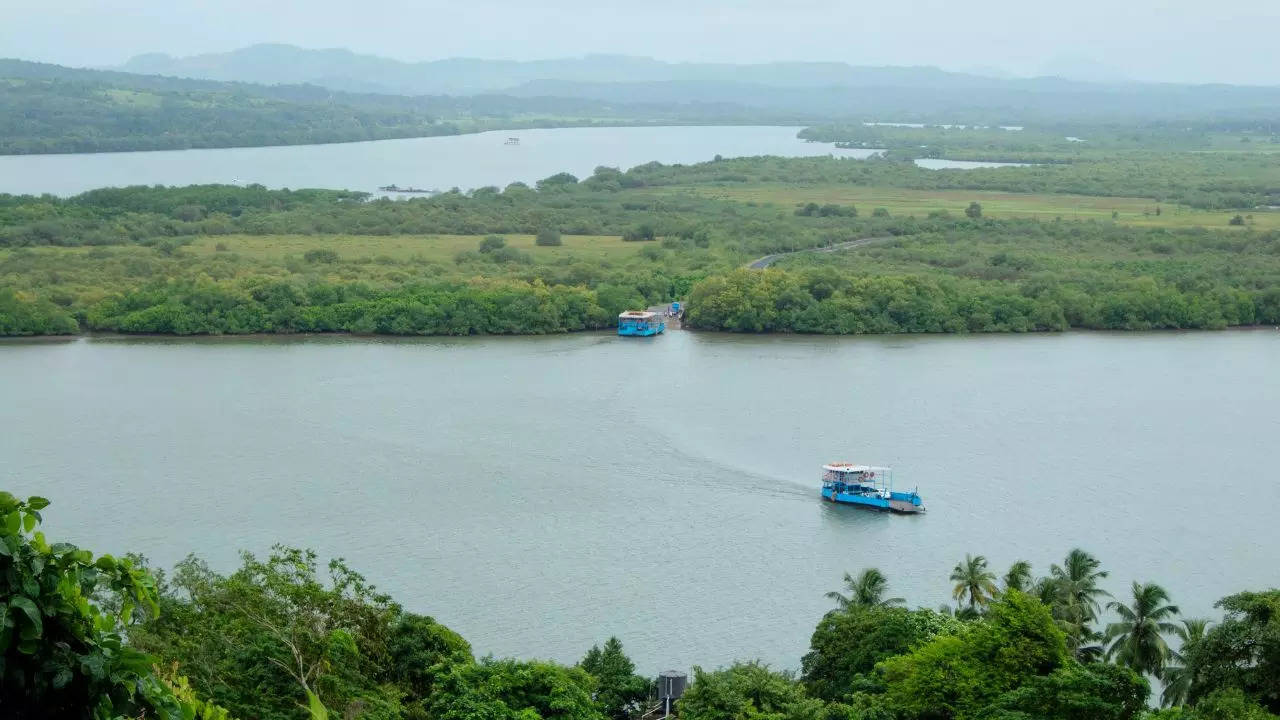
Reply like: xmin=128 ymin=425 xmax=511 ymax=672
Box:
xmin=0 ymin=126 xmax=877 ymax=195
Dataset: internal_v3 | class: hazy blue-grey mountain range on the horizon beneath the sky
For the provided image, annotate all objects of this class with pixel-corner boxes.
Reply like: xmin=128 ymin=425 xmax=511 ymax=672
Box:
xmin=122 ymin=45 xmax=1280 ymax=124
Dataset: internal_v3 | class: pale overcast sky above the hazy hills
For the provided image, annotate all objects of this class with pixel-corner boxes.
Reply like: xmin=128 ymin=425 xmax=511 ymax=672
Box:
xmin=0 ymin=0 xmax=1280 ymax=85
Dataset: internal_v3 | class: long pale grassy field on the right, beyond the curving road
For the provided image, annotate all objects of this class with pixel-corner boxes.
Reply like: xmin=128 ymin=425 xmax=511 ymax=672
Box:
xmin=650 ymin=184 xmax=1280 ymax=229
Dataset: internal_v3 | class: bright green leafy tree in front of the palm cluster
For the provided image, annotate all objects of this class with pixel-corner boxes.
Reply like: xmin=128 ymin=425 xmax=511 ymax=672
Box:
xmin=878 ymin=591 xmax=1068 ymax=719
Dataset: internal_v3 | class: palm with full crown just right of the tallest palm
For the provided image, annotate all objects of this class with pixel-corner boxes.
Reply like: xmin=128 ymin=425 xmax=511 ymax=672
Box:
xmin=1106 ymin=580 xmax=1178 ymax=678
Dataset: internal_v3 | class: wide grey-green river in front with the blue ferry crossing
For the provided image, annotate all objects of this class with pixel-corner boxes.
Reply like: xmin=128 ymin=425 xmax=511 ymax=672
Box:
xmin=0 ymin=329 xmax=1280 ymax=673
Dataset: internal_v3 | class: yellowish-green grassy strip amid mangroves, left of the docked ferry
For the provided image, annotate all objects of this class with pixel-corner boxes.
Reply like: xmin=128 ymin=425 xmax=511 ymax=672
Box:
xmin=187 ymin=234 xmax=643 ymax=264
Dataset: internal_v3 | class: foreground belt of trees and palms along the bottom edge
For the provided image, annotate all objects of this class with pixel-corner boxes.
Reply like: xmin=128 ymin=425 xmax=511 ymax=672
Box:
xmin=0 ymin=492 xmax=1280 ymax=720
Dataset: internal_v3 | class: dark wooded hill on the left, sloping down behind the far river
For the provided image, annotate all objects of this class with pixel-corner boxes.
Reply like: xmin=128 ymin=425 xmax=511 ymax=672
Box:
xmin=0 ymin=59 xmax=793 ymax=154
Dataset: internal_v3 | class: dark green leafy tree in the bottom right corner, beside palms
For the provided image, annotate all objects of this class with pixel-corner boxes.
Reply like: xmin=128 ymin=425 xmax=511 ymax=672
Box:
xmin=1183 ymin=589 xmax=1280 ymax=715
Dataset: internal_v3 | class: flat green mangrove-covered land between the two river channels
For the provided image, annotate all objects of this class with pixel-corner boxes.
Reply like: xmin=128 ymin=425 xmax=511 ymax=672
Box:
xmin=0 ymin=159 xmax=1280 ymax=334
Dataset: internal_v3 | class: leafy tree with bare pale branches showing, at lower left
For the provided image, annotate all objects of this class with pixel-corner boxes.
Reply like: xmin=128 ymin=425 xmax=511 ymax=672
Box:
xmin=131 ymin=546 xmax=401 ymax=720
